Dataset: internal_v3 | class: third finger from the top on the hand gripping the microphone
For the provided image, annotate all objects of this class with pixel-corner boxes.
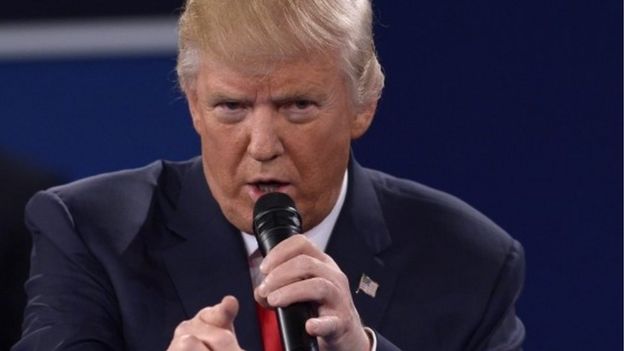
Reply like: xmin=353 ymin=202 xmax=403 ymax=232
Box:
xmin=267 ymin=278 xmax=340 ymax=307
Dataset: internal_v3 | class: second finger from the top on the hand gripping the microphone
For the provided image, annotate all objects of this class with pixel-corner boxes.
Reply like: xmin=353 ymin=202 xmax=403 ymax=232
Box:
xmin=256 ymin=255 xmax=342 ymax=298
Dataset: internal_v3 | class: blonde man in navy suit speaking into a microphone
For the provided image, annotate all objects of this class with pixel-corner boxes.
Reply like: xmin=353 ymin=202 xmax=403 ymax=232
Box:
xmin=15 ymin=0 xmax=524 ymax=350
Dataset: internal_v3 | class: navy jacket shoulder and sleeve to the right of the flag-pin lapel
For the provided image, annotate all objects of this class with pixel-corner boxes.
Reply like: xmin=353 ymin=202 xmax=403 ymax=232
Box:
xmin=354 ymin=166 xmax=524 ymax=350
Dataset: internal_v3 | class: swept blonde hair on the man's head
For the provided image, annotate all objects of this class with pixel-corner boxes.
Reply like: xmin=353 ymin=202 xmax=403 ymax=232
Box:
xmin=177 ymin=0 xmax=384 ymax=106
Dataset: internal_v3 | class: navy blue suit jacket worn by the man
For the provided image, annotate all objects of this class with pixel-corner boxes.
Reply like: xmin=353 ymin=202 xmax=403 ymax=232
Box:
xmin=14 ymin=158 xmax=524 ymax=351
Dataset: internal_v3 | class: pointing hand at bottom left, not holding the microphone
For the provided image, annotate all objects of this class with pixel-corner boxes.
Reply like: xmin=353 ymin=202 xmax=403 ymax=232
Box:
xmin=167 ymin=296 xmax=241 ymax=351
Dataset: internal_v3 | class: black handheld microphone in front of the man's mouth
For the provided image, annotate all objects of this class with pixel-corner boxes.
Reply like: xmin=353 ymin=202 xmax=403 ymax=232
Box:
xmin=253 ymin=192 xmax=319 ymax=351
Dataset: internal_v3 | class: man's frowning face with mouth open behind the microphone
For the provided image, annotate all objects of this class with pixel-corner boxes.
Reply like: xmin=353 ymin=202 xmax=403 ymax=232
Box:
xmin=188 ymin=55 xmax=375 ymax=233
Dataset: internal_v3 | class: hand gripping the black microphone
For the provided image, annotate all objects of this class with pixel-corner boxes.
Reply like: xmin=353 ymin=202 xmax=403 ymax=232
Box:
xmin=254 ymin=235 xmax=371 ymax=351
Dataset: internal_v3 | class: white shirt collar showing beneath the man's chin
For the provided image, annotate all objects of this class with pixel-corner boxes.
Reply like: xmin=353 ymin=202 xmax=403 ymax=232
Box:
xmin=241 ymin=170 xmax=349 ymax=256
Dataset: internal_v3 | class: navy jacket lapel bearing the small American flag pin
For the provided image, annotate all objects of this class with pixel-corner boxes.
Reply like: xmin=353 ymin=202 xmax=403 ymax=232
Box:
xmin=326 ymin=159 xmax=397 ymax=328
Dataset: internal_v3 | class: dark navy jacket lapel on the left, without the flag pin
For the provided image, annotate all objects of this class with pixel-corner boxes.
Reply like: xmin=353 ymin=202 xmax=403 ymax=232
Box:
xmin=162 ymin=160 xmax=262 ymax=350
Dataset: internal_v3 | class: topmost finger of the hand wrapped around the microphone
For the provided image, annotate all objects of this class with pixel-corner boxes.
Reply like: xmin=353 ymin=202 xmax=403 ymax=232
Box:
xmin=260 ymin=234 xmax=331 ymax=274
